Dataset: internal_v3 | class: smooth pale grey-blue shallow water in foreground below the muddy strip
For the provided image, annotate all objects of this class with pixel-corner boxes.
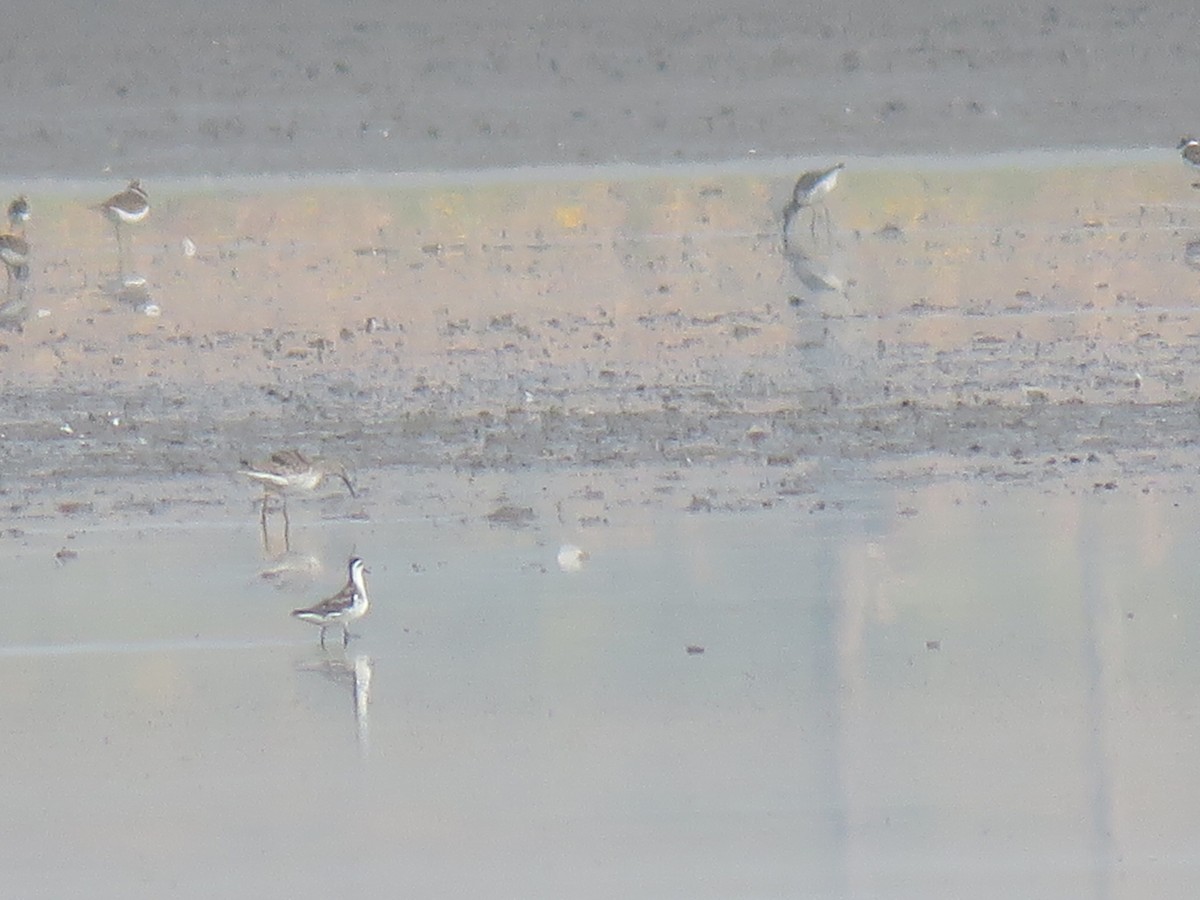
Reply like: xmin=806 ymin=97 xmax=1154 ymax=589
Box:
xmin=0 ymin=473 xmax=1200 ymax=898
